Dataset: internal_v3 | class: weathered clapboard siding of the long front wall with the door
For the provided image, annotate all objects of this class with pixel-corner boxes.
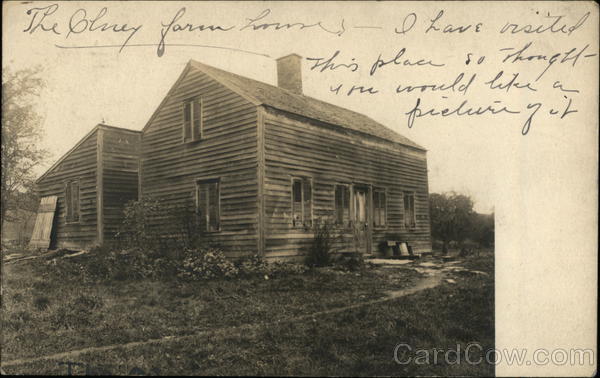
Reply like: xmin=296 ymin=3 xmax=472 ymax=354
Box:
xmin=264 ymin=108 xmax=431 ymax=258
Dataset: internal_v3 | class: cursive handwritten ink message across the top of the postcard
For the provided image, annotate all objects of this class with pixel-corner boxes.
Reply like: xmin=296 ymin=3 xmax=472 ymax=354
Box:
xmin=22 ymin=3 xmax=598 ymax=135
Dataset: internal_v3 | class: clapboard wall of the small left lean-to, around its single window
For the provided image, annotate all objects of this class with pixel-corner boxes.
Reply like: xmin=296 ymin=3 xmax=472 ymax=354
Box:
xmin=37 ymin=129 xmax=98 ymax=248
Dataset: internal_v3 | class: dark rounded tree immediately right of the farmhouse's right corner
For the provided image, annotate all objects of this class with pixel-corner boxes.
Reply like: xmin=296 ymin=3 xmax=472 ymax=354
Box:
xmin=429 ymin=192 xmax=475 ymax=253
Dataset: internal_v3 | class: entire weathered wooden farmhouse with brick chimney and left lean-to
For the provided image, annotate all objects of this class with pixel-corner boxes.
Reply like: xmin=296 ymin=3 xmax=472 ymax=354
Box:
xmin=32 ymin=54 xmax=431 ymax=258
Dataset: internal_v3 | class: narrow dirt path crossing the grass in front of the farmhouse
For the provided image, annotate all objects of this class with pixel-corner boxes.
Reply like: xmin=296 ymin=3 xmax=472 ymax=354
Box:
xmin=1 ymin=271 xmax=444 ymax=368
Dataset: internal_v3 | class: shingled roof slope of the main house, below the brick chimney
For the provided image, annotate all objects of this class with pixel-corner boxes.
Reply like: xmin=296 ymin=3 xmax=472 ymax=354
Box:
xmin=189 ymin=60 xmax=425 ymax=151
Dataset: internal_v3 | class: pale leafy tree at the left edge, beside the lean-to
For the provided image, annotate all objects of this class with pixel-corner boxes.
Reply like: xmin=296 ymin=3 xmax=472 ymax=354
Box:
xmin=1 ymin=67 xmax=46 ymax=236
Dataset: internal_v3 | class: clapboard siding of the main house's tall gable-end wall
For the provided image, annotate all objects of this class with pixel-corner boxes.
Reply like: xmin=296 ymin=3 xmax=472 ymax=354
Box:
xmin=140 ymin=66 xmax=259 ymax=256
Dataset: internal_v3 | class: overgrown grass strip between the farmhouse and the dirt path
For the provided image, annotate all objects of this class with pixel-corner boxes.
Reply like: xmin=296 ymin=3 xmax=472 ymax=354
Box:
xmin=2 ymin=256 xmax=417 ymax=360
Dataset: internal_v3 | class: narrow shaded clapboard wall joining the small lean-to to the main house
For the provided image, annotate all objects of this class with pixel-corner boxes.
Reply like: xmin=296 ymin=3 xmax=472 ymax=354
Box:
xmin=101 ymin=128 xmax=141 ymax=241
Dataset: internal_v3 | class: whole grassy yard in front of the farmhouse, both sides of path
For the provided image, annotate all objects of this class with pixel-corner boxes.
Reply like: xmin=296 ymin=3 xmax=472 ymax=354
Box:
xmin=2 ymin=254 xmax=494 ymax=376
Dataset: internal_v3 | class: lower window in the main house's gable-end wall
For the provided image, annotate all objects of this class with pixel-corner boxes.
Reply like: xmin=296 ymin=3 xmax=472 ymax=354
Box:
xmin=196 ymin=180 xmax=221 ymax=232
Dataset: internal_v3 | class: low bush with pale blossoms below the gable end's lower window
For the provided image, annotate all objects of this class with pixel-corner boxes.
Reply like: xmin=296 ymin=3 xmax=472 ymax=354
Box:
xmin=178 ymin=248 xmax=239 ymax=280
